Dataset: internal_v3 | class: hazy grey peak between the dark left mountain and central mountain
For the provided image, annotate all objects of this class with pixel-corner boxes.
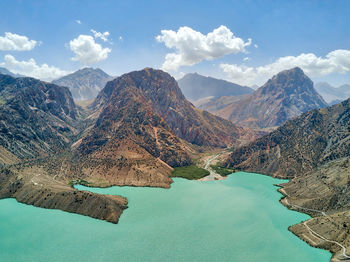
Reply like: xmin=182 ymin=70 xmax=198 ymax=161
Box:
xmin=52 ymin=68 xmax=112 ymax=100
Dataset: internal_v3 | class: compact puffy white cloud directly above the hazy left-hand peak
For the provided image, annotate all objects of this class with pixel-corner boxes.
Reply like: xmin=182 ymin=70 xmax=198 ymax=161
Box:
xmin=69 ymin=35 xmax=112 ymax=65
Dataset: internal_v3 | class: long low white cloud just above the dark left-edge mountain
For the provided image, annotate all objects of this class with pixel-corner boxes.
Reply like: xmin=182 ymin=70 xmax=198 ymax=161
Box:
xmin=0 ymin=55 xmax=70 ymax=81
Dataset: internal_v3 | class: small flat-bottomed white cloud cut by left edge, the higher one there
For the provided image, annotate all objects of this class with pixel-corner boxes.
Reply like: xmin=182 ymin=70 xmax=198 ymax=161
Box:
xmin=0 ymin=32 xmax=38 ymax=51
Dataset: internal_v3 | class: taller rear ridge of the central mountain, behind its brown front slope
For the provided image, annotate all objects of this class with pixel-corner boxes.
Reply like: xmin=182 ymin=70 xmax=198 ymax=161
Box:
xmin=93 ymin=68 xmax=255 ymax=147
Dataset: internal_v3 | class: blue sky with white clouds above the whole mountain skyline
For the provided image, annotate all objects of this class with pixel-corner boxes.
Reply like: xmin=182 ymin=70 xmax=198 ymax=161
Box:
xmin=0 ymin=0 xmax=350 ymax=86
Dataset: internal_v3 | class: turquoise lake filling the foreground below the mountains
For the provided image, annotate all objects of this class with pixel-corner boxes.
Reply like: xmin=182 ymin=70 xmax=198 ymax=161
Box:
xmin=0 ymin=172 xmax=331 ymax=262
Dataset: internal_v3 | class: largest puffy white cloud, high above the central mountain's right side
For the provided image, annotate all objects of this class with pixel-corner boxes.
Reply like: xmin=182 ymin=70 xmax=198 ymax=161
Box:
xmin=156 ymin=25 xmax=252 ymax=71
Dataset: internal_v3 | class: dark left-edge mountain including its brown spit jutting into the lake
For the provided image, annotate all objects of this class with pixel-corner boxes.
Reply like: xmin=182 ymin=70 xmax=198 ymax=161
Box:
xmin=0 ymin=75 xmax=127 ymax=223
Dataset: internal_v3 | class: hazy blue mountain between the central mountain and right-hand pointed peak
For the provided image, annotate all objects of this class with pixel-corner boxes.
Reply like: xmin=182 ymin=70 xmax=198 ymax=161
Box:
xmin=178 ymin=73 xmax=254 ymax=101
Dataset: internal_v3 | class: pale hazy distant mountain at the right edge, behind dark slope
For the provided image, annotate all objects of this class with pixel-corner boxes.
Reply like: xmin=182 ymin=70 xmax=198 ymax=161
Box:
xmin=315 ymin=82 xmax=350 ymax=105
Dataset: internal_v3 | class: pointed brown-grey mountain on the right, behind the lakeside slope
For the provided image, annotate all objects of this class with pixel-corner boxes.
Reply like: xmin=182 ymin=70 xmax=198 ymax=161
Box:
xmin=216 ymin=67 xmax=327 ymax=129
